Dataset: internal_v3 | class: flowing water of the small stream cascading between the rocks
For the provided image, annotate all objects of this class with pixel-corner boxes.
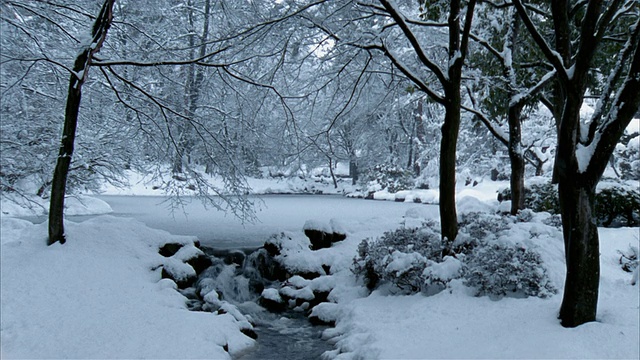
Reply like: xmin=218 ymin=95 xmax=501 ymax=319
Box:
xmin=189 ymin=247 xmax=333 ymax=360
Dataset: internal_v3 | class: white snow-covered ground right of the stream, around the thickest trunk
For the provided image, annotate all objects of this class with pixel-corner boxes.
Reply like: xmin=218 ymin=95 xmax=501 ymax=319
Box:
xmin=324 ymin=225 xmax=640 ymax=359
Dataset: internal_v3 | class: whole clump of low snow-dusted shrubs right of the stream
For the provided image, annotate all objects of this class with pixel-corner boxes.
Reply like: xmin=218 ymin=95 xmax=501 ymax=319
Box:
xmin=352 ymin=212 xmax=560 ymax=297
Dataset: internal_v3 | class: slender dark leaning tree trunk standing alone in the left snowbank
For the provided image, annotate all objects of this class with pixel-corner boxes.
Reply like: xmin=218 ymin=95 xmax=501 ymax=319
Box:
xmin=47 ymin=0 xmax=115 ymax=245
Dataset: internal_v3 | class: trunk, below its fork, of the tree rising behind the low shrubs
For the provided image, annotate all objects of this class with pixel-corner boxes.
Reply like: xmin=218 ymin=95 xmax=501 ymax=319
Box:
xmin=440 ymin=101 xmax=460 ymax=243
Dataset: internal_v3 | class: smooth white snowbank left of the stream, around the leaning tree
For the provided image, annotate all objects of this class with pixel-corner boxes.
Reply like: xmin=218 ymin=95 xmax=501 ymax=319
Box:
xmin=0 ymin=216 xmax=254 ymax=359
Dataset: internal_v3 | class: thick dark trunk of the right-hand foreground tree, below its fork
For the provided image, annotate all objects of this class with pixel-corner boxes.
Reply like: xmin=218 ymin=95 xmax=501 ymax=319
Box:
xmin=558 ymin=180 xmax=600 ymax=327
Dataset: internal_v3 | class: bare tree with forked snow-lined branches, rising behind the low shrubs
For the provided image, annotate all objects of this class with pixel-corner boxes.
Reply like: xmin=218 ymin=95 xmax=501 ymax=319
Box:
xmin=366 ymin=0 xmax=476 ymax=243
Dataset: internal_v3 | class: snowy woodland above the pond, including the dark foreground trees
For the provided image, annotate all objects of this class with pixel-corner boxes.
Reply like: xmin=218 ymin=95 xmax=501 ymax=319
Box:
xmin=0 ymin=0 xmax=640 ymax=326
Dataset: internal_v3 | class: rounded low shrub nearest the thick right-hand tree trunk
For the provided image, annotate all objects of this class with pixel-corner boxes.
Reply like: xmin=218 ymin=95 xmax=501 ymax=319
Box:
xmin=464 ymin=243 xmax=556 ymax=298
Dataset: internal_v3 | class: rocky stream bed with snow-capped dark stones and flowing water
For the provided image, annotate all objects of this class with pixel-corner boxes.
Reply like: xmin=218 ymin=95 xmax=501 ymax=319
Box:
xmin=160 ymin=223 xmax=346 ymax=360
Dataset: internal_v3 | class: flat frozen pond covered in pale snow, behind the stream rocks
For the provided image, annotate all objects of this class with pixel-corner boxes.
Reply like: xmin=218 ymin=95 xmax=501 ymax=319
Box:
xmin=91 ymin=195 xmax=437 ymax=249
